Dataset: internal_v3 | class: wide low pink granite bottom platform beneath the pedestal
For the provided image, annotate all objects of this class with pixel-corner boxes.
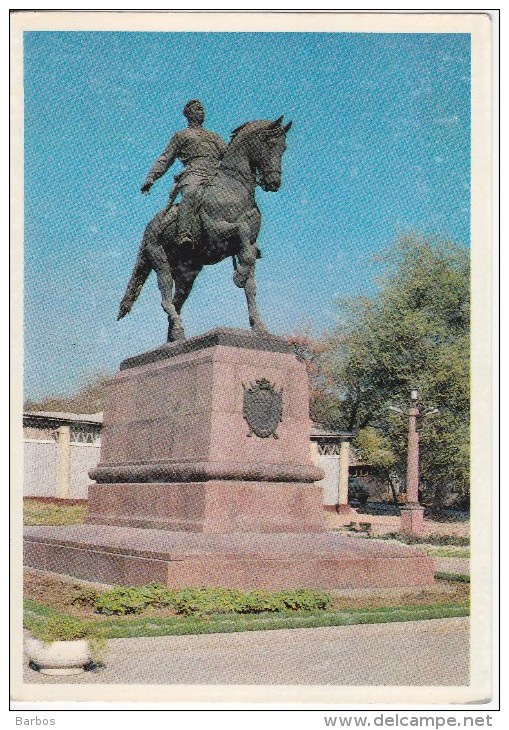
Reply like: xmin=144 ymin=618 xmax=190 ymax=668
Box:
xmin=25 ymin=525 xmax=434 ymax=590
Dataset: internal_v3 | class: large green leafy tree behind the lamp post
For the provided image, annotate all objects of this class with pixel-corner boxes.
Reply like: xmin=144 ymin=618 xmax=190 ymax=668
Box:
xmin=312 ymin=234 xmax=470 ymax=506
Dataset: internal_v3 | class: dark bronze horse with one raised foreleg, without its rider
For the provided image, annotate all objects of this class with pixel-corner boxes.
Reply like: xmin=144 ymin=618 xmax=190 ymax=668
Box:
xmin=118 ymin=117 xmax=292 ymax=342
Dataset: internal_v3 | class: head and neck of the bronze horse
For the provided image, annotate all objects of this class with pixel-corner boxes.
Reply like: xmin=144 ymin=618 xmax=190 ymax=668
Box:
xmin=228 ymin=117 xmax=292 ymax=192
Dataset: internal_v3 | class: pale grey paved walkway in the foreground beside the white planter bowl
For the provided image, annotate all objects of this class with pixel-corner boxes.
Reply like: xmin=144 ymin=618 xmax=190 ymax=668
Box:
xmin=24 ymin=618 xmax=469 ymax=686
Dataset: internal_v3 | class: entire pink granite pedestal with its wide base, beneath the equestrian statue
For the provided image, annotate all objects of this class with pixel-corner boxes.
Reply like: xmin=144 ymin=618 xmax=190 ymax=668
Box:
xmin=25 ymin=329 xmax=433 ymax=589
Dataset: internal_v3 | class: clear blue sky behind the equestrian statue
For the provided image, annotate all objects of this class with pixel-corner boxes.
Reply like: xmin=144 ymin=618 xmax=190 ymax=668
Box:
xmin=24 ymin=32 xmax=470 ymax=398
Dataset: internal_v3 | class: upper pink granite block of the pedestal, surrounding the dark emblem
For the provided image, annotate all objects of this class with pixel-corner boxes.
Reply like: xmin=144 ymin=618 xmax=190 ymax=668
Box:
xmin=92 ymin=332 xmax=320 ymax=483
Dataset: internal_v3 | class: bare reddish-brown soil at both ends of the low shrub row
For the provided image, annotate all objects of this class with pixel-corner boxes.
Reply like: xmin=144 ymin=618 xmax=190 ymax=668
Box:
xmin=23 ymin=568 xmax=470 ymax=619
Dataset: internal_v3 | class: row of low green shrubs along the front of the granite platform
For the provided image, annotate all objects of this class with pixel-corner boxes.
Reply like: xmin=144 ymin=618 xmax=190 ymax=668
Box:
xmin=88 ymin=583 xmax=331 ymax=616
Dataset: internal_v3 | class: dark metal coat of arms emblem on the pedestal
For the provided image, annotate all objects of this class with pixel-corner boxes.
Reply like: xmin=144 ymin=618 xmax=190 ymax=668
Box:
xmin=242 ymin=378 xmax=283 ymax=439
